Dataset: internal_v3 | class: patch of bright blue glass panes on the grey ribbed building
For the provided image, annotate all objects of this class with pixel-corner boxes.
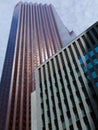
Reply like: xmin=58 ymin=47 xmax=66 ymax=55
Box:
xmin=78 ymin=45 xmax=98 ymax=87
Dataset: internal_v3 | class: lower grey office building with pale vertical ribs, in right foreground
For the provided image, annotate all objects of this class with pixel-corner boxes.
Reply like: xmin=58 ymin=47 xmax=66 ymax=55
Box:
xmin=31 ymin=22 xmax=98 ymax=130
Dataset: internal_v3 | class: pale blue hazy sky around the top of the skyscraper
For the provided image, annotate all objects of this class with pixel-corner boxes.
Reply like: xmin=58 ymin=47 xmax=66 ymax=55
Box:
xmin=0 ymin=0 xmax=98 ymax=78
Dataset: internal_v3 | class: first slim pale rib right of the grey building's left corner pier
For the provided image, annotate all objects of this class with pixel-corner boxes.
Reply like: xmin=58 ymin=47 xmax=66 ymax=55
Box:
xmin=41 ymin=67 xmax=49 ymax=130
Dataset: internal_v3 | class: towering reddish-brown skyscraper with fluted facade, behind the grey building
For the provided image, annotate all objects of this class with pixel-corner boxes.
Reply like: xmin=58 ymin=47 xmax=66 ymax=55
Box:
xmin=0 ymin=2 xmax=75 ymax=130
